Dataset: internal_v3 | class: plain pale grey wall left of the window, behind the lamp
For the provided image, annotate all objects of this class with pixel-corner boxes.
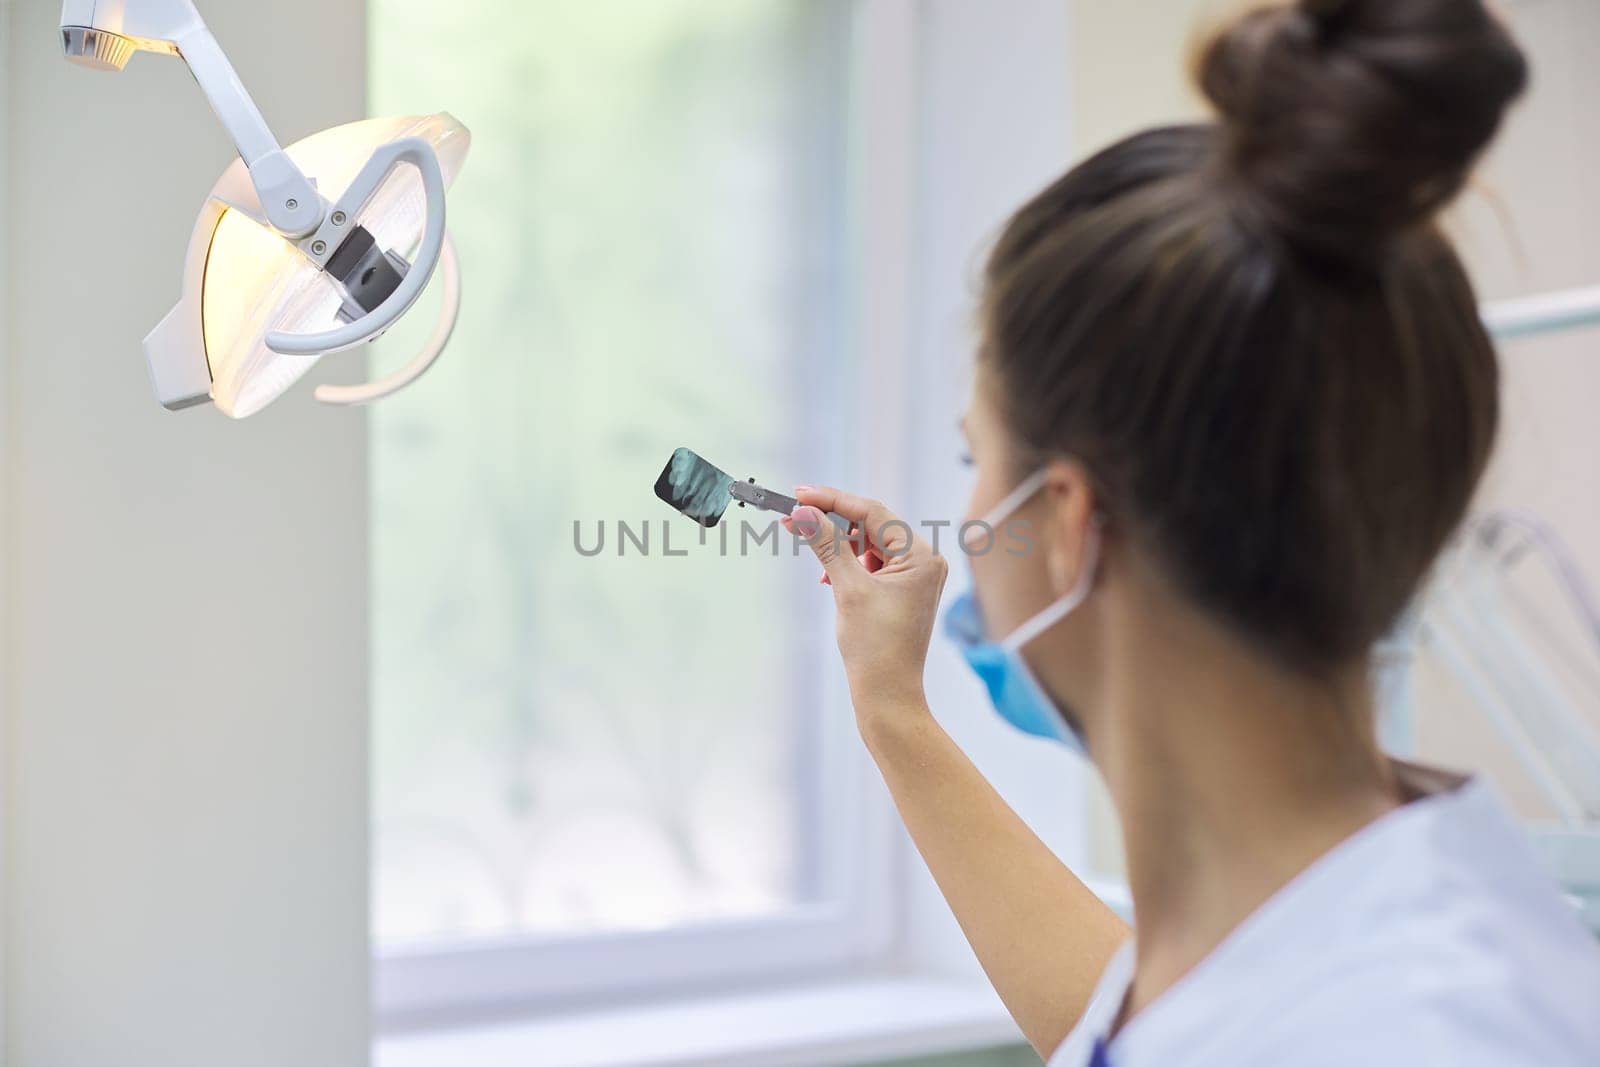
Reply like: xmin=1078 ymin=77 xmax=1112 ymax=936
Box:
xmin=0 ymin=0 xmax=368 ymax=1067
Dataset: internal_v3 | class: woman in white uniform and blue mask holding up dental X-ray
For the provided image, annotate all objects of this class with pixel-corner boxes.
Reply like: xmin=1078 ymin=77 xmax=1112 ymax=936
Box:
xmin=786 ymin=0 xmax=1600 ymax=1067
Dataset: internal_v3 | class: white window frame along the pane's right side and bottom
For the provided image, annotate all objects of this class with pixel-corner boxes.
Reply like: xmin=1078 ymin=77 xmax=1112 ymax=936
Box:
xmin=373 ymin=0 xmax=918 ymax=1032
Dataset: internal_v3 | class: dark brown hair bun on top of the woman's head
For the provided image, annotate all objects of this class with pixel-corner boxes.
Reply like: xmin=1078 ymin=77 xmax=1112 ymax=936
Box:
xmin=1197 ymin=0 xmax=1528 ymax=258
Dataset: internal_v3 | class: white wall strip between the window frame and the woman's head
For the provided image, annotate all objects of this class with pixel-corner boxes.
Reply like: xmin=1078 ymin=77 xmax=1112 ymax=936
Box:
xmin=896 ymin=0 xmax=1090 ymax=974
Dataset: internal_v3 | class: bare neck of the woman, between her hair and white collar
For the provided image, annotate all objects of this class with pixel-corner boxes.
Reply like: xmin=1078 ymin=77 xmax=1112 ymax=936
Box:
xmin=1090 ymin=585 xmax=1398 ymax=1013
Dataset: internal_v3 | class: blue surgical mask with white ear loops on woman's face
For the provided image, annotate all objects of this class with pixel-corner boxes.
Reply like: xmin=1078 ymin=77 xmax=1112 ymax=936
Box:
xmin=944 ymin=470 xmax=1099 ymax=757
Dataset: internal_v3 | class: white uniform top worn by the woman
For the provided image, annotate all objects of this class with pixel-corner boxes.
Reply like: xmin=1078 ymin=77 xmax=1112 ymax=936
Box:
xmin=1050 ymin=779 xmax=1600 ymax=1067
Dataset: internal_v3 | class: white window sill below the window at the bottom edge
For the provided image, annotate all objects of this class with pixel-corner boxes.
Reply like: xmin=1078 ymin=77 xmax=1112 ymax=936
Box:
xmin=373 ymin=977 xmax=1022 ymax=1067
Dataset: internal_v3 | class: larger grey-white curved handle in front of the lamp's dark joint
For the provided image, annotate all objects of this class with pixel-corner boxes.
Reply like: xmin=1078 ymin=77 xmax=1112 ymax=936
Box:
xmin=266 ymin=138 xmax=445 ymax=355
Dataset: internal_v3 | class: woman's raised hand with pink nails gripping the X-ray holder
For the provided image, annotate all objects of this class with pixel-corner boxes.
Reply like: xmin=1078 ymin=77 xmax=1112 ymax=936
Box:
xmin=784 ymin=486 xmax=950 ymax=729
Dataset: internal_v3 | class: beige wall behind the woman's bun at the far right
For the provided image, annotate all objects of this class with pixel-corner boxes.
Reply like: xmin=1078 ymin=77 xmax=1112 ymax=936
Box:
xmin=1418 ymin=0 xmax=1600 ymax=816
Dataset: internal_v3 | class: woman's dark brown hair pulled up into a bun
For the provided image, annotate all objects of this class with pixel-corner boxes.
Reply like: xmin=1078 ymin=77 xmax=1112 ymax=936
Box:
xmin=981 ymin=0 xmax=1528 ymax=672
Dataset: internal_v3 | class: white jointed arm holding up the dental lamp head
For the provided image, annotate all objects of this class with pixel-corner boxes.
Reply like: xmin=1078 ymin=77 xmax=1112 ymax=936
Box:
xmin=61 ymin=0 xmax=326 ymax=237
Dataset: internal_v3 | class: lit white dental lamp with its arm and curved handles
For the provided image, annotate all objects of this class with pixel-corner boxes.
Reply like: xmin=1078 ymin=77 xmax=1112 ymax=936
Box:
xmin=61 ymin=0 xmax=472 ymax=419
